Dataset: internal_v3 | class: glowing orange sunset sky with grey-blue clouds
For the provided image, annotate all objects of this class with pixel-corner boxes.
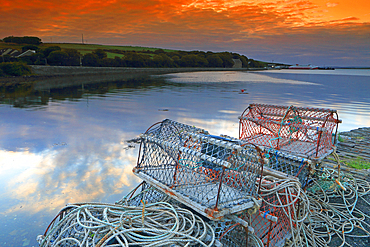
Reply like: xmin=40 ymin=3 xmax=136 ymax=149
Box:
xmin=0 ymin=0 xmax=370 ymax=66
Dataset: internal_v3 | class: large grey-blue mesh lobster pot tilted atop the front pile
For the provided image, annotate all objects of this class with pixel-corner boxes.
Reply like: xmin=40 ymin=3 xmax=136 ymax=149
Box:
xmin=133 ymin=120 xmax=264 ymax=220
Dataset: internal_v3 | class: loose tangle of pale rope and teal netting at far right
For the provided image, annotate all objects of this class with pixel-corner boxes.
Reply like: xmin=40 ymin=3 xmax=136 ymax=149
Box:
xmin=307 ymin=168 xmax=370 ymax=247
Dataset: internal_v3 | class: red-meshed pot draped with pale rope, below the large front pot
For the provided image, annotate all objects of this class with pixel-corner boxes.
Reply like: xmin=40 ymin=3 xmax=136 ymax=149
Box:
xmin=228 ymin=176 xmax=305 ymax=247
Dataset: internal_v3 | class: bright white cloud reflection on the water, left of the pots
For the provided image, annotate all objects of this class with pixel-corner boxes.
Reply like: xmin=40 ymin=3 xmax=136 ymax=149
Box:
xmin=0 ymin=138 xmax=140 ymax=214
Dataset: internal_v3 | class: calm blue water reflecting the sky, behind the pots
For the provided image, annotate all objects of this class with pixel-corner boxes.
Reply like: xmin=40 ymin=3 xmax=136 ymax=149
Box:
xmin=0 ymin=70 xmax=370 ymax=246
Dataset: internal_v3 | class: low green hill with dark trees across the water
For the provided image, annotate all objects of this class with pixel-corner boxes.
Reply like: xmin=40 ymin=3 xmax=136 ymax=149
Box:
xmin=0 ymin=39 xmax=272 ymax=68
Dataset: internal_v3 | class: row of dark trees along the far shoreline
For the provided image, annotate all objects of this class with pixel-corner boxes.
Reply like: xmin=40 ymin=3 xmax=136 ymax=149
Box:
xmin=2 ymin=36 xmax=265 ymax=68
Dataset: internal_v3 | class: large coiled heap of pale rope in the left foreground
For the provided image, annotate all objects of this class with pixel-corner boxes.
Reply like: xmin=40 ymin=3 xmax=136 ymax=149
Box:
xmin=38 ymin=202 xmax=215 ymax=247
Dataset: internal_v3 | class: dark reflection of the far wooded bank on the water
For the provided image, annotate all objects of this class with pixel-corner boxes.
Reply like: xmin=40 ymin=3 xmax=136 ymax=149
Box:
xmin=0 ymin=77 xmax=168 ymax=108
